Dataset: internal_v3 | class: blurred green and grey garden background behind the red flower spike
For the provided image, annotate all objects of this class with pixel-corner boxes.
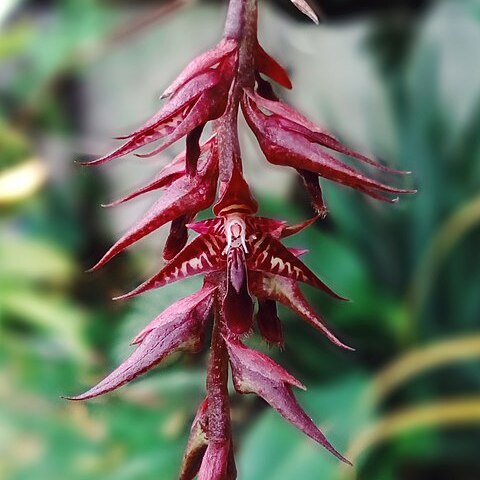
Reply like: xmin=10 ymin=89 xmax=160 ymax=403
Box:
xmin=0 ymin=0 xmax=480 ymax=480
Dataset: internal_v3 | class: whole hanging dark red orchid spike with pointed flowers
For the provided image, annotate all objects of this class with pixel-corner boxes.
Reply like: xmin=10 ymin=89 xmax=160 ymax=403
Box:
xmin=65 ymin=0 xmax=413 ymax=480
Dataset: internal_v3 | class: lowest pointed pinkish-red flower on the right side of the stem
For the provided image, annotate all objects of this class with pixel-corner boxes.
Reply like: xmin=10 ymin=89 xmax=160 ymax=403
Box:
xmin=227 ymin=339 xmax=350 ymax=464
